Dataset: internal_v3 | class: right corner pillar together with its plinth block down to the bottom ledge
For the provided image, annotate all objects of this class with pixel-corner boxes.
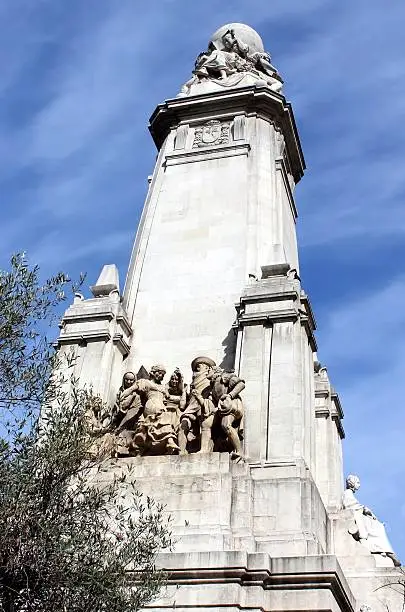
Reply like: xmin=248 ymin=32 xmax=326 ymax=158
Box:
xmin=229 ymin=263 xmax=329 ymax=555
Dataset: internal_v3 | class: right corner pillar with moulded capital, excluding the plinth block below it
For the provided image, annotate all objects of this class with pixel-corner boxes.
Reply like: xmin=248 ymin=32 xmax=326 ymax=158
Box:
xmin=235 ymin=265 xmax=316 ymax=471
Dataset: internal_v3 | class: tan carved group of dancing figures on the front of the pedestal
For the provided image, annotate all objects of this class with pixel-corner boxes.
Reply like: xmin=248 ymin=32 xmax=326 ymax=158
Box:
xmin=96 ymin=356 xmax=245 ymax=458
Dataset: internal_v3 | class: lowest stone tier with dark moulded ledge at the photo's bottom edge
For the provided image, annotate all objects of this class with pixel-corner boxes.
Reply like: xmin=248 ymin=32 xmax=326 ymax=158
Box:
xmin=147 ymin=552 xmax=356 ymax=612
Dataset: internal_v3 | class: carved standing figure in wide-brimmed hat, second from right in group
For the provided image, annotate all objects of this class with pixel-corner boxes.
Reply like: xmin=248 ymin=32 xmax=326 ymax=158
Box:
xmin=178 ymin=356 xmax=216 ymax=455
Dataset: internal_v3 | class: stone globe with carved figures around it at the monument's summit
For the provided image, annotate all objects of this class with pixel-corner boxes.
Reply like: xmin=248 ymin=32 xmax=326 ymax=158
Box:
xmin=179 ymin=23 xmax=283 ymax=97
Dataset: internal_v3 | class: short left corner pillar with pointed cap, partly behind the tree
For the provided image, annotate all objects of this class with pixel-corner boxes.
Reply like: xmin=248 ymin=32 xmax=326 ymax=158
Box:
xmin=57 ymin=265 xmax=132 ymax=403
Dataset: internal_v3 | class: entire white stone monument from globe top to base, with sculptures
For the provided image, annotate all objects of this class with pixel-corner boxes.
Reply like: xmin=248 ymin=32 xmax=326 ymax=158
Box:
xmin=59 ymin=23 xmax=402 ymax=612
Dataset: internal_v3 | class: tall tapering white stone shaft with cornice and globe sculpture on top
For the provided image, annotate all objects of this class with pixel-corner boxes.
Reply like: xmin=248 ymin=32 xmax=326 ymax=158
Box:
xmin=123 ymin=24 xmax=305 ymax=380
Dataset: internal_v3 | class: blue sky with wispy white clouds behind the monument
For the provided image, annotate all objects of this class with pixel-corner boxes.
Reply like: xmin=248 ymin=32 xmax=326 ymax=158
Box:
xmin=0 ymin=0 xmax=405 ymax=561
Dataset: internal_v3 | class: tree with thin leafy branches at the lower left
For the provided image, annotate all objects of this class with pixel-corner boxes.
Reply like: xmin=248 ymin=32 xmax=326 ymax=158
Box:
xmin=0 ymin=255 xmax=171 ymax=612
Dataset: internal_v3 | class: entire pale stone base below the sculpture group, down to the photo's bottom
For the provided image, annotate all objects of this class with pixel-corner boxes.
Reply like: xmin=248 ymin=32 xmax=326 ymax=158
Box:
xmin=98 ymin=453 xmax=402 ymax=612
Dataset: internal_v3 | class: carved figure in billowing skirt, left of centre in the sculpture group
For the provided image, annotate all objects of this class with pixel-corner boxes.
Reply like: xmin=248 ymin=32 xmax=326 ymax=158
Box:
xmin=133 ymin=365 xmax=179 ymax=455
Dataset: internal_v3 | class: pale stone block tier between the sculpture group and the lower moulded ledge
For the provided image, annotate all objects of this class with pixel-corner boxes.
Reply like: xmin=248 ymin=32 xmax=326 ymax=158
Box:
xmin=104 ymin=453 xmax=328 ymax=557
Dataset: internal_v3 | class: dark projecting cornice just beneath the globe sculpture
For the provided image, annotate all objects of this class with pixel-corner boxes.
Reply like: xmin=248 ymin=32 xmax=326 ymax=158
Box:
xmin=149 ymin=86 xmax=305 ymax=183
